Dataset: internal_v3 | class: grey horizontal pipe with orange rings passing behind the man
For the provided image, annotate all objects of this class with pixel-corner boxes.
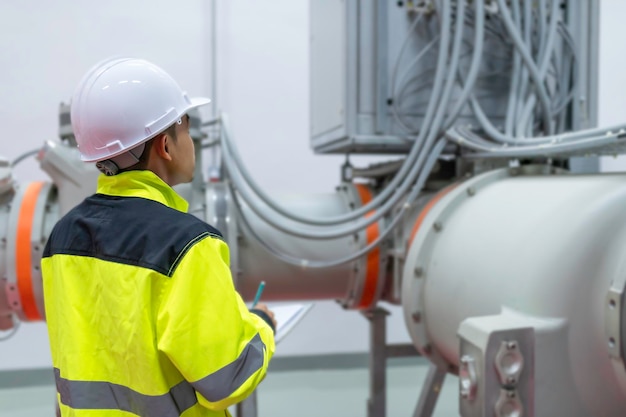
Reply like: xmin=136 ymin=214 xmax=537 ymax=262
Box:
xmin=0 ymin=142 xmax=389 ymax=330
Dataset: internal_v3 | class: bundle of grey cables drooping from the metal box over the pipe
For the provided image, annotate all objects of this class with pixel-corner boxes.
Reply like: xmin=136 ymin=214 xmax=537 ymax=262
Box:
xmin=210 ymin=0 xmax=626 ymax=268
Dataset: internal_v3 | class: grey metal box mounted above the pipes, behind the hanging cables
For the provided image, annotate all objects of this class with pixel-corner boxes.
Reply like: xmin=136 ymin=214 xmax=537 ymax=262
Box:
xmin=310 ymin=0 xmax=598 ymax=153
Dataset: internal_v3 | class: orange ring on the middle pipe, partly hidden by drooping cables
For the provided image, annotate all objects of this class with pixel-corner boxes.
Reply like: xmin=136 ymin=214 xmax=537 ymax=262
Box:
xmin=355 ymin=184 xmax=380 ymax=309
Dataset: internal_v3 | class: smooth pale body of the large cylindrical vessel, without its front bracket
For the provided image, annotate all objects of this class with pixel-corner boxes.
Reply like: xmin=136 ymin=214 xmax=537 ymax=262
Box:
xmin=402 ymin=166 xmax=626 ymax=416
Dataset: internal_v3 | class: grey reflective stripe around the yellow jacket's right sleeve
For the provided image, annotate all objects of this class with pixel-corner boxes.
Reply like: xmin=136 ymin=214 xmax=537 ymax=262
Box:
xmin=192 ymin=333 xmax=265 ymax=402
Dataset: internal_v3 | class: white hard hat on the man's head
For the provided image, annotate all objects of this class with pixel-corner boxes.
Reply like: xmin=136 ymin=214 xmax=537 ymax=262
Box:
xmin=70 ymin=58 xmax=210 ymax=162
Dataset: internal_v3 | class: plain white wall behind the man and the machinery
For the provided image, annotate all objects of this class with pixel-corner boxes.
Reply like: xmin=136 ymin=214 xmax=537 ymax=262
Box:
xmin=0 ymin=0 xmax=626 ymax=370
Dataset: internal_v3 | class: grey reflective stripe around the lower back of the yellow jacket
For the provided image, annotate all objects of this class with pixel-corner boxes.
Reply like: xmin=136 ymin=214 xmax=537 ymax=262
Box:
xmin=54 ymin=368 xmax=198 ymax=417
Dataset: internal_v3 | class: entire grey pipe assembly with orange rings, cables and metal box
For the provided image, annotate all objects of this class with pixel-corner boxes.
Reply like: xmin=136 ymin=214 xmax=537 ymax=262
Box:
xmin=6 ymin=0 xmax=626 ymax=417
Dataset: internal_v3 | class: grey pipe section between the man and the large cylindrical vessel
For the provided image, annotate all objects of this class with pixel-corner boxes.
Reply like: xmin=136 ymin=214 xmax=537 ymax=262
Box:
xmin=206 ymin=183 xmax=388 ymax=309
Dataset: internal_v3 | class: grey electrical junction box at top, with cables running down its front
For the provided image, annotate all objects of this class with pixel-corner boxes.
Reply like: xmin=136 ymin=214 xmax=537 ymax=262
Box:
xmin=310 ymin=0 xmax=599 ymax=153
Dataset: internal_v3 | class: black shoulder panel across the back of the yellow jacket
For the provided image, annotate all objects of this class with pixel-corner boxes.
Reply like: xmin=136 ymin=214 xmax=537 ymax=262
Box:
xmin=43 ymin=194 xmax=222 ymax=276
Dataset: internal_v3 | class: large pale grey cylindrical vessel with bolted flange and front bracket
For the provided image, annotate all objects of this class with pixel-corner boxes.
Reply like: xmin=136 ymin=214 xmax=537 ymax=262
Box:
xmin=402 ymin=168 xmax=626 ymax=416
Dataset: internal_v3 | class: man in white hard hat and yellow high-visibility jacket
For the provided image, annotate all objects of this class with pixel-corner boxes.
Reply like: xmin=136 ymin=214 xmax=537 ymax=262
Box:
xmin=42 ymin=58 xmax=276 ymax=417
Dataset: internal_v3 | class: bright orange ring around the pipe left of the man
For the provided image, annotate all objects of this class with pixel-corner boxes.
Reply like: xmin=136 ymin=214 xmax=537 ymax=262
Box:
xmin=15 ymin=182 xmax=44 ymax=321
